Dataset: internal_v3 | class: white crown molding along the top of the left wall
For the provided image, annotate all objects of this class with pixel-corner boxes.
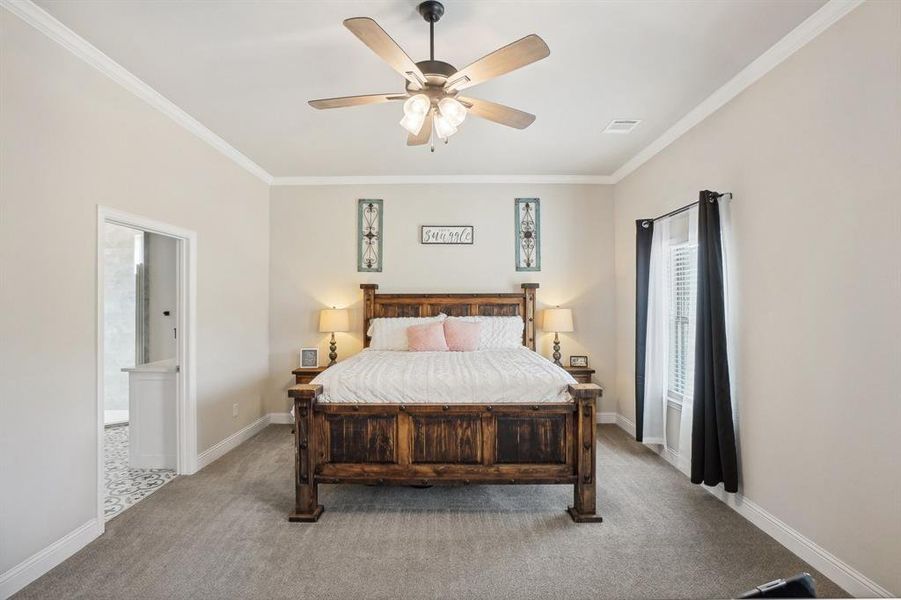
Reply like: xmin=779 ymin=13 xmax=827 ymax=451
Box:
xmin=0 ymin=0 xmax=272 ymax=184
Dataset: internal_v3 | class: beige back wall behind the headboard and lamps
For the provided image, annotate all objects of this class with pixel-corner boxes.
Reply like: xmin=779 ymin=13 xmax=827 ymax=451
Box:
xmin=268 ymin=184 xmax=616 ymax=412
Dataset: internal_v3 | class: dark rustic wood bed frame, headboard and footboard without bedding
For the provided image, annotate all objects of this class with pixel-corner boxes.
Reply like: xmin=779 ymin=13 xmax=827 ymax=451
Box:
xmin=288 ymin=283 xmax=601 ymax=522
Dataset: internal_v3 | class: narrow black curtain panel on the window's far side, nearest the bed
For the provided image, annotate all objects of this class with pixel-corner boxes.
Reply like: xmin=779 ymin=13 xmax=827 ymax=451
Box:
xmin=635 ymin=219 xmax=654 ymax=442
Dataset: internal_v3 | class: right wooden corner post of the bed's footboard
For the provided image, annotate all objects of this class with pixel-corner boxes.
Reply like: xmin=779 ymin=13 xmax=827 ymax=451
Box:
xmin=568 ymin=383 xmax=603 ymax=523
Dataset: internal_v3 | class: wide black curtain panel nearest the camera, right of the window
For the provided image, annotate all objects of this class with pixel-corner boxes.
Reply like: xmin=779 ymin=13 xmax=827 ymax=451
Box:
xmin=691 ymin=190 xmax=738 ymax=492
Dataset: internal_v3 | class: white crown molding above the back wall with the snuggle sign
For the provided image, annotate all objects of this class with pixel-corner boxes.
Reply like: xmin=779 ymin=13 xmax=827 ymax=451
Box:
xmin=268 ymin=175 xmax=615 ymax=186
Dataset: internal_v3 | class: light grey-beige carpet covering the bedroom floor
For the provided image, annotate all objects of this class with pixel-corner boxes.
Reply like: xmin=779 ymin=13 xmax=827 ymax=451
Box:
xmin=19 ymin=425 xmax=846 ymax=599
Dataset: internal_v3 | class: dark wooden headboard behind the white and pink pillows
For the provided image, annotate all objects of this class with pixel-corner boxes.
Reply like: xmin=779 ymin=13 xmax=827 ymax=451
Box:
xmin=360 ymin=283 xmax=538 ymax=350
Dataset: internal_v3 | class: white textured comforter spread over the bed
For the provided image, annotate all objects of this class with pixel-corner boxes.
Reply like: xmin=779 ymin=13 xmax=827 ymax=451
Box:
xmin=313 ymin=346 xmax=576 ymax=404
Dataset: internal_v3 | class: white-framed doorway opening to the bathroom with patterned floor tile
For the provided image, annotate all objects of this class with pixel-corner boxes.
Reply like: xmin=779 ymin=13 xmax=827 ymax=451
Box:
xmin=97 ymin=207 xmax=196 ymax=523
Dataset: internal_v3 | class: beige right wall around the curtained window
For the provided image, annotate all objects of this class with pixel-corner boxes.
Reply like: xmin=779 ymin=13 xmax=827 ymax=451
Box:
xmin=615 ymin=2 xmax=901 ymax=594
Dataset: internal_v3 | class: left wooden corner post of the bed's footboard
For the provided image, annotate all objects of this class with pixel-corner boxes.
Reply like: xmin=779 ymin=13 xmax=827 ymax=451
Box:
xmin=288 ymin=384 xmax=322 ymax=523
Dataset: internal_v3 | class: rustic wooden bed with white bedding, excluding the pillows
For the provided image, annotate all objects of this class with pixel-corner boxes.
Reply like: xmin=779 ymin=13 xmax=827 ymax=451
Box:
xmin=288 ymin=284 xmax=601 ymax=522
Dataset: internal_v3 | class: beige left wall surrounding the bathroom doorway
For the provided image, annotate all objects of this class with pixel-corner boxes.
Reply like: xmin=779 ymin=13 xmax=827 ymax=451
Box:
xmin=0 ymin=10 xmax=269 ymax=573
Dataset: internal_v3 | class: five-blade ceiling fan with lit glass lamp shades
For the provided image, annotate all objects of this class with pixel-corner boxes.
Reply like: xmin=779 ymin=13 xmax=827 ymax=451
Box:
xmin=309 ymin=0 xmax=551 ymax=152
